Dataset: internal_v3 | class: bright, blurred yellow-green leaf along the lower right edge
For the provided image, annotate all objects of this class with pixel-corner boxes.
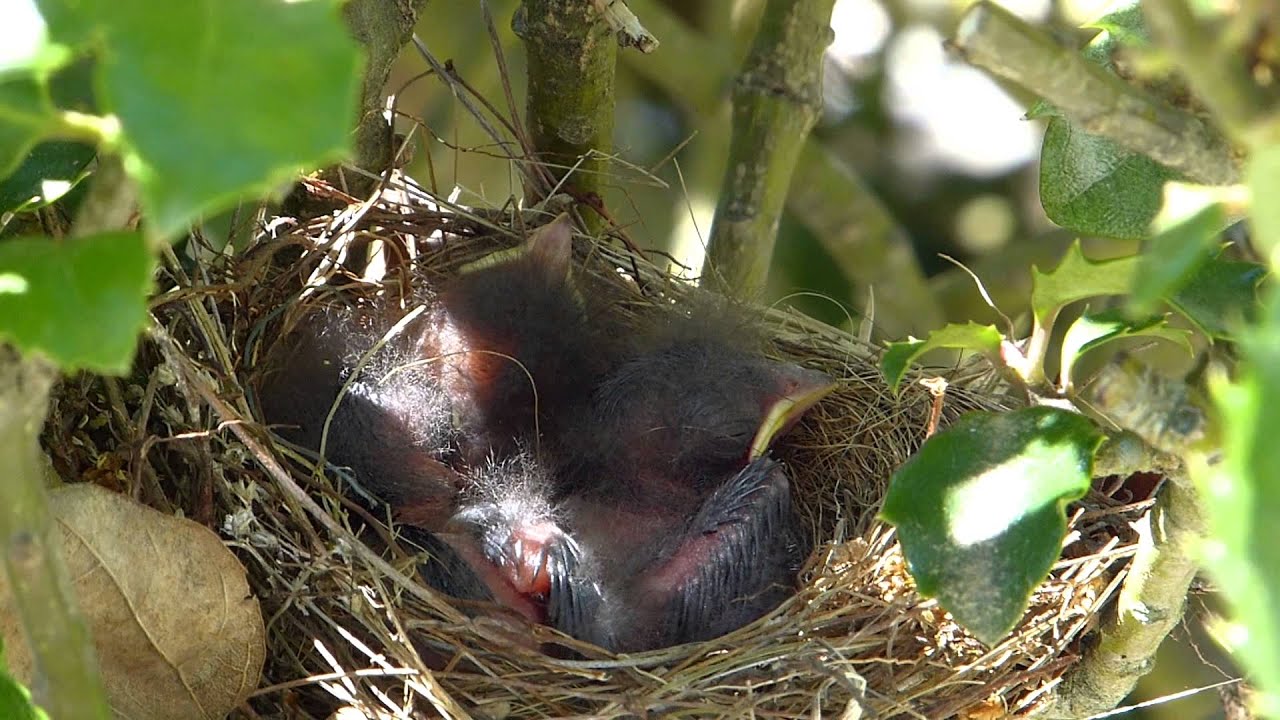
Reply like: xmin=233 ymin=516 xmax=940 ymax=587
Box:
xmin=1193 ymin=289 xmax=1280 ymax=717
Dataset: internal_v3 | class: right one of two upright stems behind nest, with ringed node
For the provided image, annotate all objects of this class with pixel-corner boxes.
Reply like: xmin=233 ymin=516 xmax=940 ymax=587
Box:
xmin=701 ymin=0 xmax=835 ymax=297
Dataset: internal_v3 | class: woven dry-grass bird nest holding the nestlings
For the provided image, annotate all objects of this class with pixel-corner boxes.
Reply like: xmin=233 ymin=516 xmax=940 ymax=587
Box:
xmin=45 ymin=175 xmax=1147 ymax=719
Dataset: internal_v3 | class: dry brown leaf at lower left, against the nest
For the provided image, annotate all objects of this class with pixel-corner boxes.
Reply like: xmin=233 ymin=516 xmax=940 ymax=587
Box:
xmin=0 ymin=483 xmax=266 ymax=720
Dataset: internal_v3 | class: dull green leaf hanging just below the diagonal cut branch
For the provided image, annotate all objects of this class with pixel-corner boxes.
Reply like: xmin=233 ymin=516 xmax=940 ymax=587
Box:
xmin=1039 ymin=118 xmax=1176 ymax=238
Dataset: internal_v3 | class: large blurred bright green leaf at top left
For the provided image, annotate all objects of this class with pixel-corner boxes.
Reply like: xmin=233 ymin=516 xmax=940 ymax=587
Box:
xmin=41 ymin=0 xmax=360 ymax=236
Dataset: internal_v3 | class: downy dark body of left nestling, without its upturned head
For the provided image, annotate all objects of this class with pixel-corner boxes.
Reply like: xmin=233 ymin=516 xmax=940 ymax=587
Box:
xmin=257 ymin=297 xmax=462 ymax=527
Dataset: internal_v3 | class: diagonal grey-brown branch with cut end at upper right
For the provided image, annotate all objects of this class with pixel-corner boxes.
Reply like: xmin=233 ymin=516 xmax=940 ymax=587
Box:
xmin=952 ymin=0 xmax=1240 ymax=184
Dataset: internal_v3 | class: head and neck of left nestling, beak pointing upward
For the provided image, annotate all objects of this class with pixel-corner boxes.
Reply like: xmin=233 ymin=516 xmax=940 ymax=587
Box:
xmin=421 ymin=215 xmax=604 ymax=466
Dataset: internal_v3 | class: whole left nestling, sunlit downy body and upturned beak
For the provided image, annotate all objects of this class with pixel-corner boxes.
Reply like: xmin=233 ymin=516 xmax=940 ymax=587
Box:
xmin=259 ymin=217 xmax=593 ymax=529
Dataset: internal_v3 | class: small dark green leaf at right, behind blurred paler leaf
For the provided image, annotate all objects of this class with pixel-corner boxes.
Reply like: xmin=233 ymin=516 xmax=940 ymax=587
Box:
xmin=1166 ymin=258 xmax=1267 ymax=338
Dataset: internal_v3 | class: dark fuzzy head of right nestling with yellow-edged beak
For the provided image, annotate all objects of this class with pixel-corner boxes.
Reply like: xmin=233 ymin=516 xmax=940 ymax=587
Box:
xmin=563 ymin=311 xmax=835 ymax=498
